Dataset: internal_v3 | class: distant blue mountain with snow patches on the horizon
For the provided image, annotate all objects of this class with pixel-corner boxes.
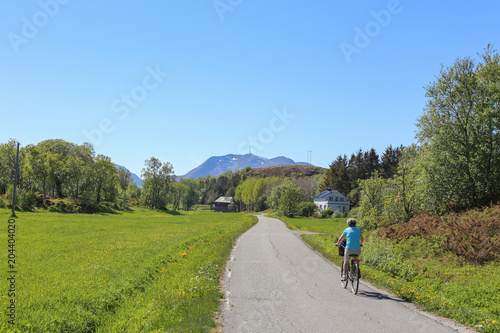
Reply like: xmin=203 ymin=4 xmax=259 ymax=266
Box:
xmin=182 ymin=154 xmax=309 ymax=178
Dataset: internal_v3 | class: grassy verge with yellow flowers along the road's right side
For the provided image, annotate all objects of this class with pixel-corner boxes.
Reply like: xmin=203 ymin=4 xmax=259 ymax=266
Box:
xmin=282 ymin=214 xmax=500 ymax=333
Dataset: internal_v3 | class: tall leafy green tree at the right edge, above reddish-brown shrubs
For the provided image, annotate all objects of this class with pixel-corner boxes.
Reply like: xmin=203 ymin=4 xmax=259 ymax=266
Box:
xmin=417 ymin=46 xmax=500 ymax=211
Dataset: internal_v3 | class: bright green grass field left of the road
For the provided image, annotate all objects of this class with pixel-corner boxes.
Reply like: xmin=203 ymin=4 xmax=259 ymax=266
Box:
xmin=0 ymin=209 xmax=257 ymax=332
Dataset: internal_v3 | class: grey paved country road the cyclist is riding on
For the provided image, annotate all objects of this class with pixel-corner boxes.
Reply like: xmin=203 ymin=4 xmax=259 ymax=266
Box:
xmin=221 ymin=216 xmax=473 ymax=333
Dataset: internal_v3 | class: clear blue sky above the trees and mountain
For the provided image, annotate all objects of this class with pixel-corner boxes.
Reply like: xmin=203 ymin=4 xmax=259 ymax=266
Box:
xmin=0 ymin=0 xmax=500 ymax=175
